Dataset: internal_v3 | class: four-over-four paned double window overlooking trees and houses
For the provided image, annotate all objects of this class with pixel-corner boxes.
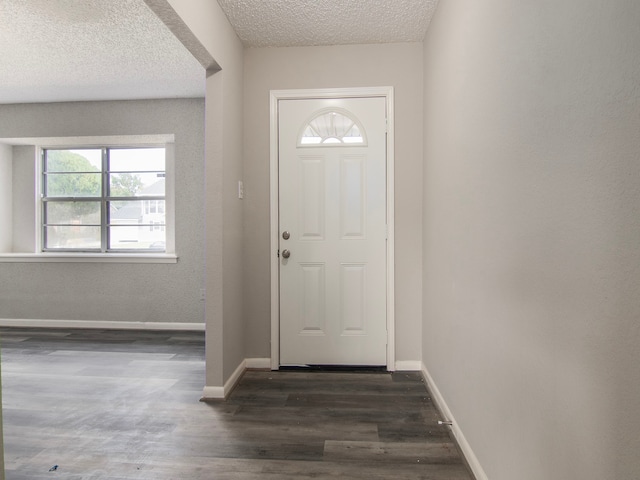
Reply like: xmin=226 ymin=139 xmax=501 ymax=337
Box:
xmin=41 ymin=146 xmax=167 ymax=253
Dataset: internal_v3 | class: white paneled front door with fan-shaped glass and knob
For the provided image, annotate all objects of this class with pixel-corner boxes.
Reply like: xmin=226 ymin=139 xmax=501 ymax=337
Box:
xmin=278 ymin=97 xmax=387 ymax=365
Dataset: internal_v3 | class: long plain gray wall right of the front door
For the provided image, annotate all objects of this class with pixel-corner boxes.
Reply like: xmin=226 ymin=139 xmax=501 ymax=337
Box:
xmin=423 ymin=0 xmax=640 ymax=480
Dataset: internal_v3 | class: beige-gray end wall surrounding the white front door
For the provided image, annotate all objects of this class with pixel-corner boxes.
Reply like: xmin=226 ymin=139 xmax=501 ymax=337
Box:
xmin=244 ymin=43 xmax=423 ymax=361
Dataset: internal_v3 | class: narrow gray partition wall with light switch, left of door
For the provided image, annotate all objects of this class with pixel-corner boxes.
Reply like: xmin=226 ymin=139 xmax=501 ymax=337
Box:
xmin=165 ymin=0 xmax=246 ymax=386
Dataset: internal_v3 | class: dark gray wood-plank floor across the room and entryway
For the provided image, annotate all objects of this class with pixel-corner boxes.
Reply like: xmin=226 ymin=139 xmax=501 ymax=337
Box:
xmin=0 ymin=328 xmax=472 ymax=480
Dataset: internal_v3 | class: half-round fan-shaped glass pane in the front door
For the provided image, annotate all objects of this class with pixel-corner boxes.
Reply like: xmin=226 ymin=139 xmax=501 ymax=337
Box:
xmin=298 ymin=108 xmax=367 ymax=147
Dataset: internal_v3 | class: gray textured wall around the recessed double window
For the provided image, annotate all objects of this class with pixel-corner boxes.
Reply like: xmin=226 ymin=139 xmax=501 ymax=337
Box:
xmin=0 ymin=99 xmax=204 ymax=323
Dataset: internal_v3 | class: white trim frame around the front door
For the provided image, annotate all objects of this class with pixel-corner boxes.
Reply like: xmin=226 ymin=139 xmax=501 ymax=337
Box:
xmin=270 ymin=87 xmax=395 ymax=371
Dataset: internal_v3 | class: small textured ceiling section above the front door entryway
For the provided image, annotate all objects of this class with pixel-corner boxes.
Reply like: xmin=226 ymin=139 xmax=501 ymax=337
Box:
xmin=218 ymin=0 xmax=438 ymax=47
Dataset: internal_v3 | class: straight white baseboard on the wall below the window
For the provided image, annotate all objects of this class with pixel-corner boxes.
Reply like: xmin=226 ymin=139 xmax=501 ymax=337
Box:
xmin=0 ymin=318 xmax=205 ymax=332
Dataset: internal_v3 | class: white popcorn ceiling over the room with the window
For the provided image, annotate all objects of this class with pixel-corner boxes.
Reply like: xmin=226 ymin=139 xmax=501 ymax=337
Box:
xmin=0 ymin=0 xmax=205 ymax=103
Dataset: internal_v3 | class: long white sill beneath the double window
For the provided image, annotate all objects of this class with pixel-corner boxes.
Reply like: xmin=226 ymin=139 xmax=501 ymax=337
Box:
xmin=0 ymin=253 xmax=178 ymax=263
